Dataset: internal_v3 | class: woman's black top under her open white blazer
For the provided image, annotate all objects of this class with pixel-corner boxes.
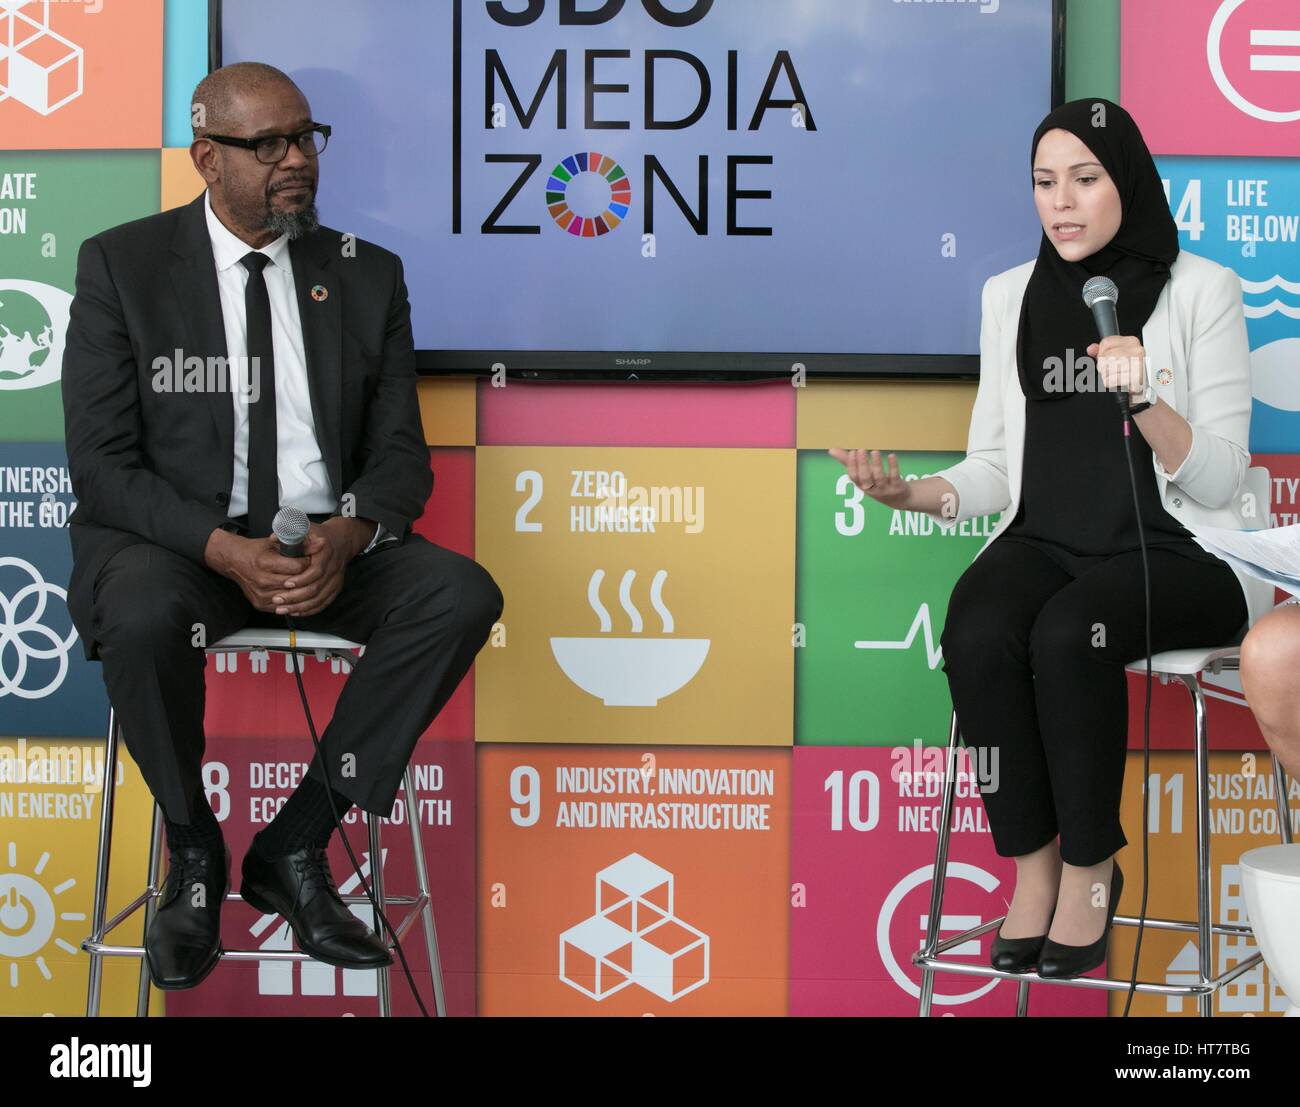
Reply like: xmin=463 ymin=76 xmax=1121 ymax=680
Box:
xmin=1004 ymin=391 xmax=1222 ymax=566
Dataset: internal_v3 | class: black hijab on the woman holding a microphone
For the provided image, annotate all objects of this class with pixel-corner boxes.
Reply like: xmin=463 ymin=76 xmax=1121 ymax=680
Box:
xmin=1015 ymin=97 xmax=1178 ymax=400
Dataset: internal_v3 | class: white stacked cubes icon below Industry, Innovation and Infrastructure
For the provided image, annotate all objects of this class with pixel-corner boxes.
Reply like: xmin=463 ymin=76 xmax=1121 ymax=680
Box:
xmin=560 ymin=854 xmax=709 ymax=1003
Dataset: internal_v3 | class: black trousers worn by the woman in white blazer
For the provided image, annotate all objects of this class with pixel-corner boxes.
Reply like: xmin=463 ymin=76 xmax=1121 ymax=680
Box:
xmin=940 ymin=537 xmax=1249 ymax=865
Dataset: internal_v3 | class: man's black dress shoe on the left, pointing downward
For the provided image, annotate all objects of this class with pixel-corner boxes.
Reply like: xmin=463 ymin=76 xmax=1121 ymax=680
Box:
xmin=144 ymin=842 xmax=230 ymax=991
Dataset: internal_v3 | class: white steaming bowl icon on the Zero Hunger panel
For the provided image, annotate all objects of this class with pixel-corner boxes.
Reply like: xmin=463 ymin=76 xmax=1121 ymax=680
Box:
xmin=551 ymin=569 xmax=711 ymax=707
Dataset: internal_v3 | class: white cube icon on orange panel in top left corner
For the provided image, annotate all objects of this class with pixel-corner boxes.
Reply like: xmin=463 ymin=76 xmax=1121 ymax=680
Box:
xmin=0 ymin=0 xmax=86 ymax=116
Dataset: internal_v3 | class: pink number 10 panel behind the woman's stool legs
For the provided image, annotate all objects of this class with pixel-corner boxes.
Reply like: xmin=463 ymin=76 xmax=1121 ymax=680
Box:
xmin=790 ymin=746 xmax=1106 ymax=1016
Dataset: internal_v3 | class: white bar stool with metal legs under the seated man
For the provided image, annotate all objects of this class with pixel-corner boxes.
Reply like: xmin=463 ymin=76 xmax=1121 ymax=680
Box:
xmin=81 ymin=628 xmax=447 ymax=1019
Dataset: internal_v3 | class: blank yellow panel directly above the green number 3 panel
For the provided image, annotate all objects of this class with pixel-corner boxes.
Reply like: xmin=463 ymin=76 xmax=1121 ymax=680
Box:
xmin=796 ymin=381 xmax=975 ymax=451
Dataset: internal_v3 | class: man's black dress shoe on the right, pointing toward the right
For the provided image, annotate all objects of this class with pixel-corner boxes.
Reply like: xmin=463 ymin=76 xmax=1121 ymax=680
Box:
xmin=239 ymin=841 xmax=393 ymax=969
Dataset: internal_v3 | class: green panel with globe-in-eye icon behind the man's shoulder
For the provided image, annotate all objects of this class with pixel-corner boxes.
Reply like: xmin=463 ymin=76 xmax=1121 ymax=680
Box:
xmin=0 ymin=151 xmax=161 ymax=442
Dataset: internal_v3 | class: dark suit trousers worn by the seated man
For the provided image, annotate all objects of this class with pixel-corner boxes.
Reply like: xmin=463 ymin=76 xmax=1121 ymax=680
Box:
xmin=94 ymin=534 xmax=504 ymax=824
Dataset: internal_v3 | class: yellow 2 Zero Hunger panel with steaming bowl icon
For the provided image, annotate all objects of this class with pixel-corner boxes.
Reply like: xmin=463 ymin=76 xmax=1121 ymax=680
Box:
xmin=475 ymin=446 xmax=796 ymax=746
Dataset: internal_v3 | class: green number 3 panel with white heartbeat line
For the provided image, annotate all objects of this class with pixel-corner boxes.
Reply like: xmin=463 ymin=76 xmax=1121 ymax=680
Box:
xmin=794 ymin=450 xmax=998 ymax=746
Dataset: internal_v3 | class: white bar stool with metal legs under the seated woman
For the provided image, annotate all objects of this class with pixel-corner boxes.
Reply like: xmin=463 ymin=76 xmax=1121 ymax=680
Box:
xmin=911 ymin=646 xmax=1291 ymax=1019
